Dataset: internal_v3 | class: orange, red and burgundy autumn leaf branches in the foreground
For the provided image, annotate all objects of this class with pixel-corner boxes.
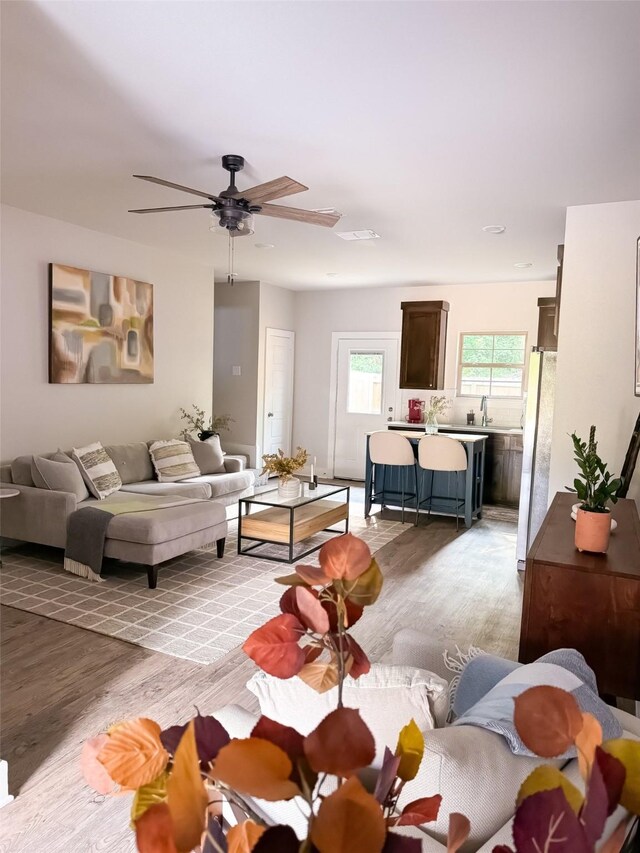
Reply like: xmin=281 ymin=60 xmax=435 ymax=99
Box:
xmin=82 ymin=534 xmax=640 ymax=853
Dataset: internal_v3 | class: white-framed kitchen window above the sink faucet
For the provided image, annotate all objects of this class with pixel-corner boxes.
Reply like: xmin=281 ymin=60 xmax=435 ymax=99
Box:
xmin=458 ymin=332 xmax=527 ymax=397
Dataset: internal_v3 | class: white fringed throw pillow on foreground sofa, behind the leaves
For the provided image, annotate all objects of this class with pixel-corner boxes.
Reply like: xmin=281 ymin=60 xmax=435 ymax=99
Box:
xmin=247 ymin=664 xmax=447 ymax=766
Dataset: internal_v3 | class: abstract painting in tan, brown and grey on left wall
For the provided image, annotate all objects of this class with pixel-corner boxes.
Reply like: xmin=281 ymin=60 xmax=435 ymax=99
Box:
xmin=49 ymin=264 xmax=153 ymax=384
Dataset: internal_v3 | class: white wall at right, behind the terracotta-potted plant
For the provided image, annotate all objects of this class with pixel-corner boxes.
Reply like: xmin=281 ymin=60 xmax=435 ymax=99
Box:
xmin=549 ymin=201 xmax=640 ymax=501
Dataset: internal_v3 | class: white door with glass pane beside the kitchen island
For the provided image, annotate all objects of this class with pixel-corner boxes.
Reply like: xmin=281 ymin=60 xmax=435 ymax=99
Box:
xmin=333 ymin=337 xmax=399 ymax=480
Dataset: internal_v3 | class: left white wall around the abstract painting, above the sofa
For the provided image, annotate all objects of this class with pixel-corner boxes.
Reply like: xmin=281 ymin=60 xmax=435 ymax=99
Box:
xmin=0 ymin=206 xmax=213 ymax=461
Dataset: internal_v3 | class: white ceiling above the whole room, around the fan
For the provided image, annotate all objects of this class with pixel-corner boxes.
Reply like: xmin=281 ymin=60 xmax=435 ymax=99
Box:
xmin=1 ymin=0 xmax=640 ymax=289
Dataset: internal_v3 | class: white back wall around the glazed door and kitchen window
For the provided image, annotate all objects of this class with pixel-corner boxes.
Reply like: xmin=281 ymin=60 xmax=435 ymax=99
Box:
xmin=294 ymin=281 xmax=555 ymax=473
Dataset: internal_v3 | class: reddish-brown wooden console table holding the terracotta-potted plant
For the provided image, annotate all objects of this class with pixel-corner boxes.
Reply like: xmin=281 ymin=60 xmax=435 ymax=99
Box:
xmin=518 ymin=492 xmax=640 ymax=700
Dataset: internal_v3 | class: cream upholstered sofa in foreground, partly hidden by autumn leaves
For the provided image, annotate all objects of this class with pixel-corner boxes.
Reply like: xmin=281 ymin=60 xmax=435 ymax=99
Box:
xmin=209 ymin=629 xmax=640 ymax=853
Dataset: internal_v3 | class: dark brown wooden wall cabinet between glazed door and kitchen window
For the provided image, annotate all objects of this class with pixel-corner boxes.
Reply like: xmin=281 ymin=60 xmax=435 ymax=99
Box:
xmin=400 ymin=302 xmax=449 ymax=389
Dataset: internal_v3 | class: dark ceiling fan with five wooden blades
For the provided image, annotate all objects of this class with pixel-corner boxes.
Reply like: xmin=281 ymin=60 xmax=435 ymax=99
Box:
xmin=129 ymin=154 xmax=340 ymax=237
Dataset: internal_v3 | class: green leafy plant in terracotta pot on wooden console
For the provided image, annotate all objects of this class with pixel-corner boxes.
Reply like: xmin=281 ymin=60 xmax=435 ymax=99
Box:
xmin=568 ymin=426 xmax=621 ymax=554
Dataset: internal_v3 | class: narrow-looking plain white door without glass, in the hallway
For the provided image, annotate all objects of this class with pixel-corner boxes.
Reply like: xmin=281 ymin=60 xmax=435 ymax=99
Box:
xmin=262 ymin=329 xmax=295 ymax=455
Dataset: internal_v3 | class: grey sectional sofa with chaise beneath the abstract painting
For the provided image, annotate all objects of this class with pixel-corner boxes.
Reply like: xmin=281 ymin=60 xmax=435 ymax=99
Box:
xmin=0 ymin=442 xmax=255 ymax=589
